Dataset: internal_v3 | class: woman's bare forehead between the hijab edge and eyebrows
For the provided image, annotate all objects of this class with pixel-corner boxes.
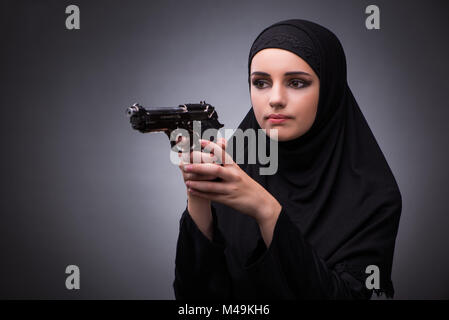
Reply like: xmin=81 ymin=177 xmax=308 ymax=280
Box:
xmin=251 ymin=48 xmax=314 ymax=74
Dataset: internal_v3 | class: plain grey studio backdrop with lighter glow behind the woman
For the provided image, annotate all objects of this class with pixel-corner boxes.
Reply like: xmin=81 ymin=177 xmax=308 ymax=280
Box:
xmin=0 ymin=0 xmax=449 ymax=299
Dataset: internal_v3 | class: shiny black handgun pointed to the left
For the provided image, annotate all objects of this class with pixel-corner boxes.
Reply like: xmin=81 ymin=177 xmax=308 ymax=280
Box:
xmin=126 ymin=101 xmax=224 ymax=151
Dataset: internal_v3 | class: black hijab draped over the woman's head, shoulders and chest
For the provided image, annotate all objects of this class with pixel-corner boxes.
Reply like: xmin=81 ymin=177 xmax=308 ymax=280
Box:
xmin=213 ymin=19 xmax=402 ymax=297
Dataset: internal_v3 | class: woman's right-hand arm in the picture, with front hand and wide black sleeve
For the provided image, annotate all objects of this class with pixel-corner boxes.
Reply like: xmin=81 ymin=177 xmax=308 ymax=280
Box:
xmin=181 ymin=140 xmax=384 ymax=299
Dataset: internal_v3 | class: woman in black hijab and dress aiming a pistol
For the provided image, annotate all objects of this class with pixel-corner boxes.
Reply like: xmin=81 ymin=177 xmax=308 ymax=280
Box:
xmin=173 ymin=19 xmax=402 ymax=299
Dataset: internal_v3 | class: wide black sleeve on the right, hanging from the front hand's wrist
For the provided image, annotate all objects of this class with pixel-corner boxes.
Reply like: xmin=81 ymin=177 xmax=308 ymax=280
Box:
xmin=245 ymin=208 xmax=372 ymax=300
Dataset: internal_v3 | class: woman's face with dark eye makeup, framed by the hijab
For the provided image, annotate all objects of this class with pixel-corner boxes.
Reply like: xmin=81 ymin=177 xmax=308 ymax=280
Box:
xmin=250 ymin=48 xmax=320 ymax=141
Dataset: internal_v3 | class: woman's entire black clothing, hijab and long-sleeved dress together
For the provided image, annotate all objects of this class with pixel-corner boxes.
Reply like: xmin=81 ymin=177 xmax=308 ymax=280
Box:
xmin=173 ymin=19 xmax=402 ymax=299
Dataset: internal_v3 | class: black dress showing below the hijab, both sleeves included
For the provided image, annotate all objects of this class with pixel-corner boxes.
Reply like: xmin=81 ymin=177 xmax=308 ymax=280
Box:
xmin=173 ymin=202 xmax=372 ymax=300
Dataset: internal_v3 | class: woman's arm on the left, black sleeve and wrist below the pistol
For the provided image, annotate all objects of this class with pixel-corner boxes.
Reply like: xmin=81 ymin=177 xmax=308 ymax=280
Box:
xmin=173 ymin=140 xmax=231 ymax=299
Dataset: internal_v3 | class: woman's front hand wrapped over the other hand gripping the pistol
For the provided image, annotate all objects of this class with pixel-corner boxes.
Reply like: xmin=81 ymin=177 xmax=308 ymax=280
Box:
xmin=184 ymin=139 xmax=281 ymax=223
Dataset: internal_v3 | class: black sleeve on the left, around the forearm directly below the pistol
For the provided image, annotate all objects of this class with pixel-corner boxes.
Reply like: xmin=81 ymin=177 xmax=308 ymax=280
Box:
xmin=173 ymin=206 xmax=231 ymax=300
